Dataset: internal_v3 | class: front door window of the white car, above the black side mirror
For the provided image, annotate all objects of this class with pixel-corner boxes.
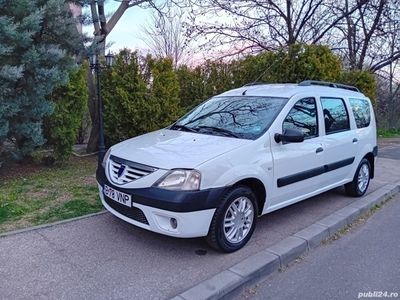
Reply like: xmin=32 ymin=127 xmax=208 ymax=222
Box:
xmin=283 ymin=98 xmax=318 ymax=138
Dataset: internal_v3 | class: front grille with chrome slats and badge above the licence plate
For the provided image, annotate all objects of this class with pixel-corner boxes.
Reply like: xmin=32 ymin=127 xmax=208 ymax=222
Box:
xmin=108 ymin=155 xmax=157 ymax=185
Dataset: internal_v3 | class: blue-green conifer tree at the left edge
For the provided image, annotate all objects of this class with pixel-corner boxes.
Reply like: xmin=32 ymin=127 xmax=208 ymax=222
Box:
xmin=0 ymin=0 xmax=82 ymax=157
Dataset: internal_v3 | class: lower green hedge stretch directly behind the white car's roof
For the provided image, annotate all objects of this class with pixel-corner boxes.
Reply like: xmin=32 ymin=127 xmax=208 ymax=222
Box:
xmin=176 ymin=44 xmax=376 ymax=109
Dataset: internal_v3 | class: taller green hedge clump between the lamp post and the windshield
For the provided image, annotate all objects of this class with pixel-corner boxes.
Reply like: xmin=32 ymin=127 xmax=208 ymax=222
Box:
xmin=101 ymin=49 xmax=181 ymax=146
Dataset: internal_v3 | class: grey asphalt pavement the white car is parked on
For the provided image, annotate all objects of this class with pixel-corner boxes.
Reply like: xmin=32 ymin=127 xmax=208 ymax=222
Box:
xmin=0 ymin=141 xmax=400 ymax=299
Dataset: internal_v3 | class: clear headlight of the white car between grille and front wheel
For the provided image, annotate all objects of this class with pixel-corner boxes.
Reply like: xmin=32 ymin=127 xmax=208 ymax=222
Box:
xmin=154 ymin=170 xmax=201 ymax=191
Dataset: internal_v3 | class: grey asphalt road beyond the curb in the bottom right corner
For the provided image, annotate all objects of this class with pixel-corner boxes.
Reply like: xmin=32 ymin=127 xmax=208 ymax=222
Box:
xmin=237 ymin=196 xmax=400 ymax=300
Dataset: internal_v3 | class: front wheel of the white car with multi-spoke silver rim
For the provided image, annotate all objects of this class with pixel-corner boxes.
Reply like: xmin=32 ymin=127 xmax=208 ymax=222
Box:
xmin=207 ymin=186 xmax=258 ymax=252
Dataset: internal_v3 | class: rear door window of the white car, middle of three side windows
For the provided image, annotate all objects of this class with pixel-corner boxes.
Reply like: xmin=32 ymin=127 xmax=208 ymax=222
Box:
xmin=321 ymin=98 xmax=350 ymax=134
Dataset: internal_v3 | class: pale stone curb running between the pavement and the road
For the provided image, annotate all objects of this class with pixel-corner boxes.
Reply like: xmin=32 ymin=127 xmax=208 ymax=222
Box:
xmin=172 ymin=182 xmax=400 ymax=300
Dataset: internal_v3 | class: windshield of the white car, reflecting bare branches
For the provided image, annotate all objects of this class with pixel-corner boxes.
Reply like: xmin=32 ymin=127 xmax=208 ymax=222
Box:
xmin=169 ymin=96 xmax=287 ymax=139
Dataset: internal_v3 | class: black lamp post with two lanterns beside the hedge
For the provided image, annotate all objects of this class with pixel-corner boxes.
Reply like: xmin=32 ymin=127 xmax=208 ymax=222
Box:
xmin=89 ymin=52 xmax=114 ymax=167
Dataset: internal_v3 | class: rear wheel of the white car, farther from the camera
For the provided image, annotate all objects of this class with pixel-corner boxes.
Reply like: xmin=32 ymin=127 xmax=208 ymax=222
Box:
xmin=345 ymin=158 xmax=371 ymax=197
